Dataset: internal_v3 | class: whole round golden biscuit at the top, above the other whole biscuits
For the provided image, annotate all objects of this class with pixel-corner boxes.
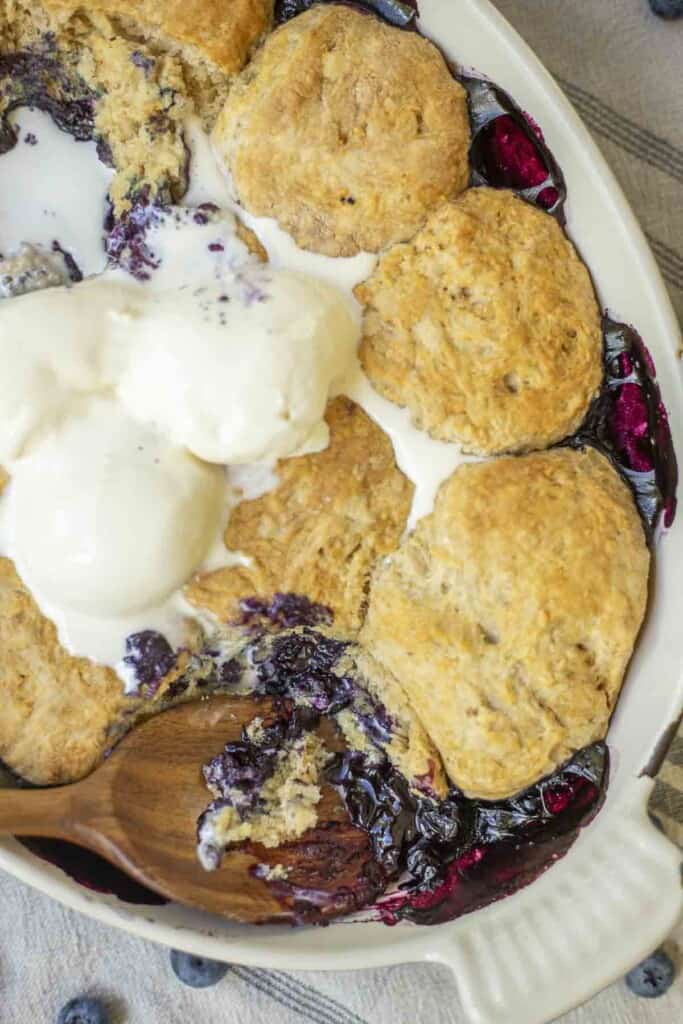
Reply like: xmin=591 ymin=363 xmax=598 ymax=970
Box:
xmin=213 ymin=5 xmax=470 ymax=256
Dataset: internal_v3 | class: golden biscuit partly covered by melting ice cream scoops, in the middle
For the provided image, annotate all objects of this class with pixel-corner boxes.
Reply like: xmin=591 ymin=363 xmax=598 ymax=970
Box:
xmin=185 ymin=398 xmax=413 ymax=631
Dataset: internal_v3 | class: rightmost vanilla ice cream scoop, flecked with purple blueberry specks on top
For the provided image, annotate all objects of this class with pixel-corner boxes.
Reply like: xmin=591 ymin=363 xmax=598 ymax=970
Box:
xmin=117 ymin=266 xmax=358 ymax=464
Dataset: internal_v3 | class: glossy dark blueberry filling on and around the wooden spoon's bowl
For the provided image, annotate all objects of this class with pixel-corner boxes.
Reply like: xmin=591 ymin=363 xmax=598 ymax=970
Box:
xmin=192 ymin=629 xmax=608 ymax=924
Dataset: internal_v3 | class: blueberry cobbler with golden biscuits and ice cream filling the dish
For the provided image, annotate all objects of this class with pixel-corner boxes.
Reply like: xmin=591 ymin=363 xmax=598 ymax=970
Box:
xmin=0 ymin=0 xmax=677 ymax=925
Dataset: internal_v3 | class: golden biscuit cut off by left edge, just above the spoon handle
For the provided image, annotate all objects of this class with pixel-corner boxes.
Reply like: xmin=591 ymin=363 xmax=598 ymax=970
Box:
xmin=0 ymin=558 xmax=126 ymax=784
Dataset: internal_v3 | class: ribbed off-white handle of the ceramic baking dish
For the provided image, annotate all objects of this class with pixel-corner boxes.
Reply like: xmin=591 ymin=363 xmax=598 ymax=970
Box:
xmin=427 ymin=777 xmax=683 ymax=1024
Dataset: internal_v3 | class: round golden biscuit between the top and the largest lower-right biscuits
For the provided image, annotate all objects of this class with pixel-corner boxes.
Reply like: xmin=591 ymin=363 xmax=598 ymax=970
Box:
xmin=355 ymin=188 xmax=602 ymax=454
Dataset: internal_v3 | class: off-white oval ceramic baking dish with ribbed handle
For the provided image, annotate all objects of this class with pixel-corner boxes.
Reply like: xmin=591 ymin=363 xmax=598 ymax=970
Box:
xmin=0 ymin=0 xmax=683 ymax=1024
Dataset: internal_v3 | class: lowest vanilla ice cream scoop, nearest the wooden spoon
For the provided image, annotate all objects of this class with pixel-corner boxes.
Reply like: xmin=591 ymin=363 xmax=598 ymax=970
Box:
xmin=3 ymin=399 xmax=225 ymax=616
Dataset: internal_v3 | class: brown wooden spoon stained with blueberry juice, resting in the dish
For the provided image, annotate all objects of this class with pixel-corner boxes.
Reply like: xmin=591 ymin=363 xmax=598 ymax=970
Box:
xmin=0 ymin=696 xmax=382 ymax=923
